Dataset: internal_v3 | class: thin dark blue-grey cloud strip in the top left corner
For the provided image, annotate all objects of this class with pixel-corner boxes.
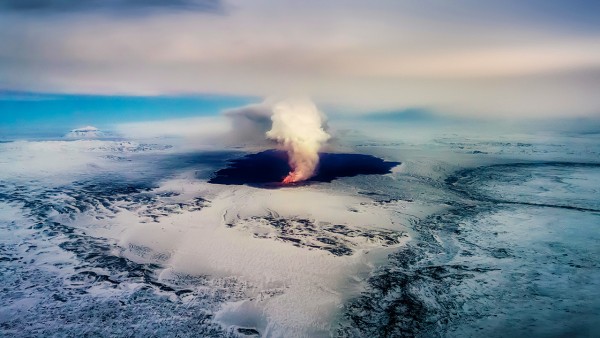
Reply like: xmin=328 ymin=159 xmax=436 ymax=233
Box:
xmin=0 ymin=0 xmax=222 ymax=14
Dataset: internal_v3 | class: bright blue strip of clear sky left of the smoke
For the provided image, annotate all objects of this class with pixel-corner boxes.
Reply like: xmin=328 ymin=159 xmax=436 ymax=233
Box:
xmin=0 ymin=92 xmax=255 ymax=138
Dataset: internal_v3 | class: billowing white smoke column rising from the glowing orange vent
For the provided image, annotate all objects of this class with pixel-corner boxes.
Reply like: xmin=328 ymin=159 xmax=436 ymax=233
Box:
xmin=267 ymin=99 xmax=330 ymax=183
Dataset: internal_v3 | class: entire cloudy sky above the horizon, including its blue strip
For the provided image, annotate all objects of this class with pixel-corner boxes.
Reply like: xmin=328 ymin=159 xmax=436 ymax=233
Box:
xmin=0 ymin=0 xmax=600 ymax=128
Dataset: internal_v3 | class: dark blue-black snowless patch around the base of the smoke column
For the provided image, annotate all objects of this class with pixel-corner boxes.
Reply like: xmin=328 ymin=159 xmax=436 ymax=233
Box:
xmin=209 ymin=150 xmax=400 ymax=186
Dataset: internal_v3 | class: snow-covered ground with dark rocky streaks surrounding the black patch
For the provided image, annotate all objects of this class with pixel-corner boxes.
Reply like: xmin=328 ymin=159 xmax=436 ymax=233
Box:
xmin=0 ymin=131 xmax=600 ymax=337
